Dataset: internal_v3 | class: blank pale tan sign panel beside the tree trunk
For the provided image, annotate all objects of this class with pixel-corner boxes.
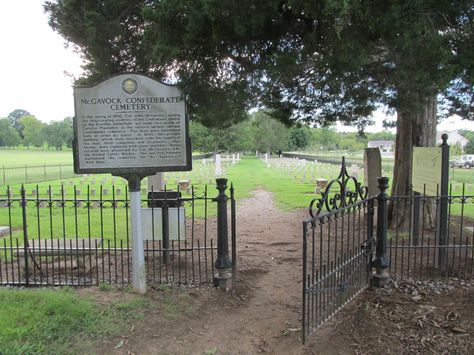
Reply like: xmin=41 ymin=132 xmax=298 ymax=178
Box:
xmin=412 ymin=147 xmax=441 ymax=196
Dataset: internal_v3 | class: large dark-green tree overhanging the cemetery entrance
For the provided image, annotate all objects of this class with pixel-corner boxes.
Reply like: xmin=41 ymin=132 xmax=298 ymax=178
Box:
xmin=45 ymin=0 xmax=474 ymax=225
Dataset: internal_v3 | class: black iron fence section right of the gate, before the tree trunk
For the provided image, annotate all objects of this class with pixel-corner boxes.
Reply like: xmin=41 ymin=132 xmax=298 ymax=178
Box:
xmin=387 ymin=190 xmax=474 ymax=280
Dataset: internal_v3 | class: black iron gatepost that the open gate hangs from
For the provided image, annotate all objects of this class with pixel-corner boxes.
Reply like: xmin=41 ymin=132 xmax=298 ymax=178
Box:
xmin=370 ymin=177 xmax=390 ymax=287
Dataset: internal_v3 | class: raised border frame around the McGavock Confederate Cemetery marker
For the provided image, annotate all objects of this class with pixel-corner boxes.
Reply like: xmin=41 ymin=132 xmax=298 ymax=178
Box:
xmin=73 ymin=72 xmax=192 ymax=179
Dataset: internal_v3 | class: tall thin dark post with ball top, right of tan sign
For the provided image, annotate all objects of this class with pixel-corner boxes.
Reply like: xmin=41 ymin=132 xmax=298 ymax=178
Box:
xmin=437 ymin=133 xmax=449 ymax=271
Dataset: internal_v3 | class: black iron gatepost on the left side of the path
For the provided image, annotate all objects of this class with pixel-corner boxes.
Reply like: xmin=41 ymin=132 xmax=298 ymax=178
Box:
xmin=214 ymin=178 xmax=232 ymax=290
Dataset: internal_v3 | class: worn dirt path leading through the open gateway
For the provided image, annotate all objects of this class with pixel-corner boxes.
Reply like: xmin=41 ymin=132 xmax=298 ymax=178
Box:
xmin=99 ymin=190 xmax=305 ymax=354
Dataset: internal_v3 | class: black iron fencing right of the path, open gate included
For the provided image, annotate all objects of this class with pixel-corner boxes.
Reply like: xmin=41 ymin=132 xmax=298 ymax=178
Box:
xmin=302 ymin=158 xmax=474 ymax=342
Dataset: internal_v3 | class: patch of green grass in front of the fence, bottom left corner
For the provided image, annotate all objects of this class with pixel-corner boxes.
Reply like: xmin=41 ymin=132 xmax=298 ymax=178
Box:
xmin=0 ymin=288 xmax=150 ymax=355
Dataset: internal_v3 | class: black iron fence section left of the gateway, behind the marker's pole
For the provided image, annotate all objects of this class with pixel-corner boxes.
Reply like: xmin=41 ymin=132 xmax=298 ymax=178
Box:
xmin=0 ymin=182 xmax=236 ymax=287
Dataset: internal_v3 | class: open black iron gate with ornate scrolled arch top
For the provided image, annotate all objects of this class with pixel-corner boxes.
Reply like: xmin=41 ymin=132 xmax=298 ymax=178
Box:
xmin=302 ymin=157 xmax=375 ymax=343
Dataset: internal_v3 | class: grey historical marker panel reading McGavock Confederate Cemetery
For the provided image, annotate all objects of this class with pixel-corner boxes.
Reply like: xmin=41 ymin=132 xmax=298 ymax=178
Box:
xmin=74 ymin=74 xmax=192 ymax=176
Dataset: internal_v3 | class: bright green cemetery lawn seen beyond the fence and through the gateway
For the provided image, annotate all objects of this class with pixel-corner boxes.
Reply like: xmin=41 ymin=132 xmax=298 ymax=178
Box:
xmin=0 ymin=157 xmax=474 ymax=247
